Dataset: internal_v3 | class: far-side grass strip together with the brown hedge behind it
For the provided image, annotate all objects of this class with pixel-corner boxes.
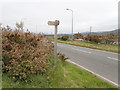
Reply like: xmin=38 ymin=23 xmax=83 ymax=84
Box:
xmin=55 ymin=33 xmax=120 ymax=53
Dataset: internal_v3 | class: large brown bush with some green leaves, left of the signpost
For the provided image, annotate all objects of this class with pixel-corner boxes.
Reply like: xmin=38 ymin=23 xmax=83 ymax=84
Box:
xmin=2 ymin=28 xmax=53 ymax=80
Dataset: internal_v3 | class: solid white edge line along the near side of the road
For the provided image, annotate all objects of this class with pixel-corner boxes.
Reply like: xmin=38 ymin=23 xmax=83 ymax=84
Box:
xmin=66 ymin=60 xmax=118 ymax=86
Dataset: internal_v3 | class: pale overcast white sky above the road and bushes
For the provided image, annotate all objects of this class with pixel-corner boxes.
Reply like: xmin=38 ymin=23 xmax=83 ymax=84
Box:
xmin=0 ymin=0 xmax=119 ymax=34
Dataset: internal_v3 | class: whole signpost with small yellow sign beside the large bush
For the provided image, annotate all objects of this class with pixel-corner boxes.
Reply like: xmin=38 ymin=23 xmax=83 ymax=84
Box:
xmin=48 ymin=20 xmax=60 ymax=64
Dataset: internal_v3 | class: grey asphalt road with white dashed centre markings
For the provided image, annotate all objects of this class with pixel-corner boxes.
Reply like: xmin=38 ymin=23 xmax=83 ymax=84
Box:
xmin=57 ymin=43 xmax=119 ymax=84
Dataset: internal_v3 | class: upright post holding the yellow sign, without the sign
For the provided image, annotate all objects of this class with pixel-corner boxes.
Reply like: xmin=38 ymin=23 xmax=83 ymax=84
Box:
xmin=54 ymin=25 xmax=57 ymax=64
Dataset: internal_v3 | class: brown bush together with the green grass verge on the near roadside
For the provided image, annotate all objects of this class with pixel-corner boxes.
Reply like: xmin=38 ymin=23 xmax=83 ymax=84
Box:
xmin=2 ymin=26 xmax=116 ymax=88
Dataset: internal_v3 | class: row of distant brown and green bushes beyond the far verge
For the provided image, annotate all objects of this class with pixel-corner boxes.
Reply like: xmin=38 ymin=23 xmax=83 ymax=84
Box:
xmin=50 ymin=32 xmax=120 ymax=45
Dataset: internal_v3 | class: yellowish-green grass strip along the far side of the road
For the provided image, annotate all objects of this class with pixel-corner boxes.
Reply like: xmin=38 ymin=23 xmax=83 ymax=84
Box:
xmin=58 ymin=40 xmax=120 ymax=53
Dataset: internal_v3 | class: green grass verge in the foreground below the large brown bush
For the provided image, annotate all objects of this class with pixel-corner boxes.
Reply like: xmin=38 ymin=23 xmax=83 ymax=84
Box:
xmin=2 ymin=57 xmax=117 ymax=88
